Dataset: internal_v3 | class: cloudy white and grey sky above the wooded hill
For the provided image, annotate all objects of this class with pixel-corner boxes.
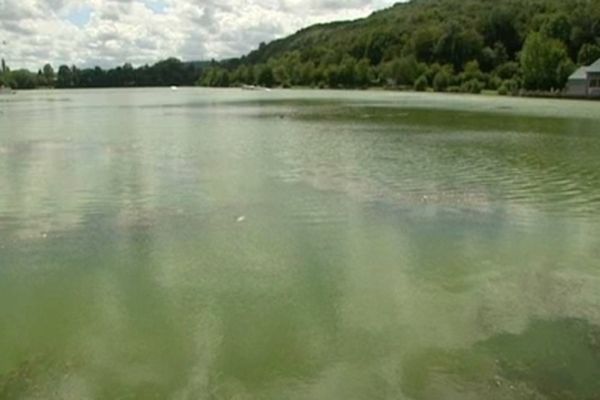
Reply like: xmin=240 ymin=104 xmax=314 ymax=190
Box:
xmin=0 ymin=0 xmax=397 ymax=69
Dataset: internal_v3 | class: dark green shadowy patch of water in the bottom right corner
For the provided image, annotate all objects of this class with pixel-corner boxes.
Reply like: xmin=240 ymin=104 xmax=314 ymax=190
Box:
xmin=403 ymin=319 xmax=600 ymax=400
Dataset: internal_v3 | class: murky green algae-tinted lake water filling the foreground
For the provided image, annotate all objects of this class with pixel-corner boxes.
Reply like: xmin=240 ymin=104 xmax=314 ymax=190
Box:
xmin=0 ymin=89 xmax=600 ymax=400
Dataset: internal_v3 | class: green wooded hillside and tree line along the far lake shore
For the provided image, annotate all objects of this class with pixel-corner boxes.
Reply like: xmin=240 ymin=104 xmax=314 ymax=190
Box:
xmin=0 ymin=0 xmax=600 ymax=94
